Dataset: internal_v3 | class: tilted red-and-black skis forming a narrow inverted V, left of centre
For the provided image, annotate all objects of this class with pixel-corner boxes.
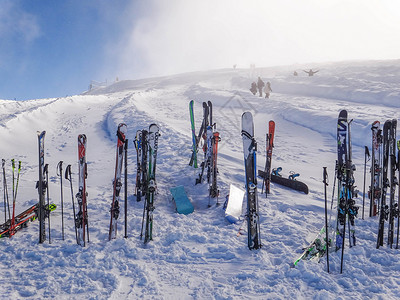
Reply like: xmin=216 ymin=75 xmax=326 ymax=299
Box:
xmin=108 ymin=123 xmax=128 ymax=240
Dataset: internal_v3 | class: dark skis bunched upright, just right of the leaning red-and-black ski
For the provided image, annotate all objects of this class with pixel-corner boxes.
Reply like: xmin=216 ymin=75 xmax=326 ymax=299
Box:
xmin=134 ymin=124 xmax=160 ymax=244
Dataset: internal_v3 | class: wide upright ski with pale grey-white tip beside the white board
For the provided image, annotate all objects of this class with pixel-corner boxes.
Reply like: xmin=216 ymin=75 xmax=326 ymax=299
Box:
xmin=241 ymin=112 xmax=261 ymax=250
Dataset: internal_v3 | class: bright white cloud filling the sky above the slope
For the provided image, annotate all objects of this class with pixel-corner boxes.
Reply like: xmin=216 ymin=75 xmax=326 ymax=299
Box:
xmin=113 ymin=0 xmax=400 ymax=77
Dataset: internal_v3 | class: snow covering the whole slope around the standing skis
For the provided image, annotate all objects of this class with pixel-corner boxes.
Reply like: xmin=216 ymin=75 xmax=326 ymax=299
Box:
xmin=0 ymin=60 xmax=400 ymax=299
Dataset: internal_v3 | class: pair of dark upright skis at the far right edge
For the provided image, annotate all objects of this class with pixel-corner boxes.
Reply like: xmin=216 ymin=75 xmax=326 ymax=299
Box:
xmin=376 ymin=119 xmax=400 ymax=248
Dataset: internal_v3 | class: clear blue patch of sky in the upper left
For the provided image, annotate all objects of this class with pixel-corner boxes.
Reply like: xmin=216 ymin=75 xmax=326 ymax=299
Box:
xmin=0 ymin=0 xmax=141 ymax=100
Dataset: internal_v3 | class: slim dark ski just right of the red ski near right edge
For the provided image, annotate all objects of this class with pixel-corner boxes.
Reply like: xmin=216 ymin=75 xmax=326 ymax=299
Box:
xmin=376 ymin=120 xmax=392 ymax=248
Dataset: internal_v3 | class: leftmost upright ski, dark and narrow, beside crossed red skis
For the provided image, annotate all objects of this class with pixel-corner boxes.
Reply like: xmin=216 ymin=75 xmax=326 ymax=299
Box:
xmin=36 ymin=131 xmax=46 ymax=244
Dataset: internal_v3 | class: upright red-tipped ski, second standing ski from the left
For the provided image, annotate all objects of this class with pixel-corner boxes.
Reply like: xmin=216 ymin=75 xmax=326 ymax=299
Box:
xmin=75 ymin=134 xmax=89 ymax=247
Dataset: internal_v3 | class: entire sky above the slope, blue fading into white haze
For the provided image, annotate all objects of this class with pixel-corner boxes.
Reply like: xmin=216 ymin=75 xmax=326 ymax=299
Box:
xmin=0 ymin=0 xmax=400 ymax=99
